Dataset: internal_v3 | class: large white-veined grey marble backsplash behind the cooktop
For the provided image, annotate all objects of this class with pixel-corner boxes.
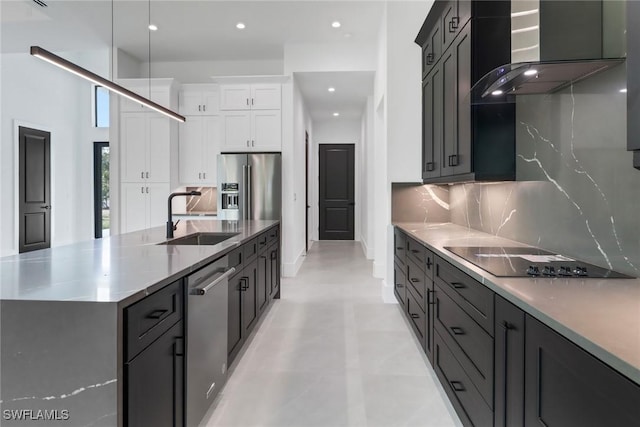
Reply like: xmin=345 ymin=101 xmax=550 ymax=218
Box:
xmin=449 ymin=65 xmax=640 ymax=276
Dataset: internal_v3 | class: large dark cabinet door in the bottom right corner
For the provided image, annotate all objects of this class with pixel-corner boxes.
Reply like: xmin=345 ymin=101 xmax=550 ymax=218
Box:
xmin=525 ymin=315 xmax=640 ymax=427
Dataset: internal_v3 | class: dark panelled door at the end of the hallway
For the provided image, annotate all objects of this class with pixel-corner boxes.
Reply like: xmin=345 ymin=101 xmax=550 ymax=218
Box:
xmin=319 ymin=144 xmax=355 ymax=240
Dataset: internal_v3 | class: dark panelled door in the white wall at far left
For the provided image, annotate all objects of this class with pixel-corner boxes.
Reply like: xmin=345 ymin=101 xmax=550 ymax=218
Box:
xmin=18 ymin=127 xmax=51 ymax=253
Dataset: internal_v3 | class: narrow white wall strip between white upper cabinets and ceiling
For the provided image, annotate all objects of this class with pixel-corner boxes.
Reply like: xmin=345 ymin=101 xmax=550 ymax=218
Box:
xmin=146 ymin=60 xmax=284 ymax=83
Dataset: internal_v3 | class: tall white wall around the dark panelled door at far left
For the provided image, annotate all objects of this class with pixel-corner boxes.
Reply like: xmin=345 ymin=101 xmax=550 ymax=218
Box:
xmin=0 ymin=49 xmax=109 ymax=256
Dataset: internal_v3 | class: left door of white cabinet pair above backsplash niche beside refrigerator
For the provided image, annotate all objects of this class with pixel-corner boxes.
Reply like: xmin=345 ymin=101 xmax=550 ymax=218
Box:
xmin=178 ymin=116 xmax=206 ymax=185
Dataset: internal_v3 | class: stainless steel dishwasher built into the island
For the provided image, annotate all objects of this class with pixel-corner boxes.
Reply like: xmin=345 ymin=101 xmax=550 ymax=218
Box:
xmin=185 ymin=256 xmax=235 ymax=427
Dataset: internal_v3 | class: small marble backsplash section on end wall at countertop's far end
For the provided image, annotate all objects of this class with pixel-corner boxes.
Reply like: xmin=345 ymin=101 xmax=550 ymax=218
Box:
xmin=391 ymin=183 xmax=451 ymax=222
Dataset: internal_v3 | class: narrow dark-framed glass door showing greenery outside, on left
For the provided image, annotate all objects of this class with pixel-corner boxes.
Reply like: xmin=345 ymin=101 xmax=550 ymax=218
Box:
xmin=93 ymin=142 xmax=111 ymax=239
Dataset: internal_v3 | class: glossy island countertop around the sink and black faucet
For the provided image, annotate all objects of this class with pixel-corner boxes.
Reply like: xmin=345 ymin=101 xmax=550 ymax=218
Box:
xmin=0 ymin=220 xmax=279 ymax=305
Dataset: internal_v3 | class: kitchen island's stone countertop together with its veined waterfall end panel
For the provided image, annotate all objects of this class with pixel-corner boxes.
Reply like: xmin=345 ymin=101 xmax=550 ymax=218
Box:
xmin=0 ymin=220 xmax=279 ymax=426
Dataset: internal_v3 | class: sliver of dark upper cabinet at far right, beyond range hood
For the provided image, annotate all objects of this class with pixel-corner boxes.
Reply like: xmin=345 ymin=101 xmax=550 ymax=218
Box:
xmin=627 ymin=1 xmax=640 ymax=169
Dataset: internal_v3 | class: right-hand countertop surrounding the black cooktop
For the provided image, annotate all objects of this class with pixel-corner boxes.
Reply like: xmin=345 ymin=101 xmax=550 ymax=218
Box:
xmin=394 ymin=223 xmax=640 ymax=384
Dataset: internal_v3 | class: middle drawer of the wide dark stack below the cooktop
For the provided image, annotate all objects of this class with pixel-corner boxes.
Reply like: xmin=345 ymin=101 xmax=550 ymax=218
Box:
xmin=434 ymin=285 xmax=493 ymax=408
